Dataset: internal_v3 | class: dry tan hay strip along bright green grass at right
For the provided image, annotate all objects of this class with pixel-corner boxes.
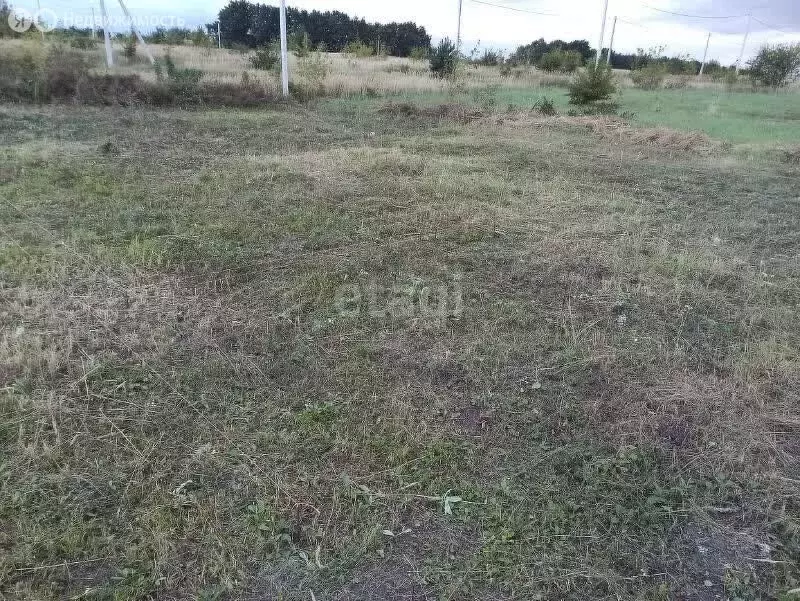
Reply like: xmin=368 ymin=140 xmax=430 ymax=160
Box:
xmin=567 ymin=116 xmax=722 ymax=154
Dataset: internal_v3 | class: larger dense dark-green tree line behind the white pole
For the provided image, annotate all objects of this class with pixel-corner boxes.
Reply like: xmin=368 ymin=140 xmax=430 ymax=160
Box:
xmin=212 ymin=0 xmax=431 ymax=56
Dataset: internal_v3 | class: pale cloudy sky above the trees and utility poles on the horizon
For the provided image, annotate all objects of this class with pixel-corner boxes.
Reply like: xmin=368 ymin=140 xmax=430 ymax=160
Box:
xmin=13 ymin=0 xmax=800 ymax=64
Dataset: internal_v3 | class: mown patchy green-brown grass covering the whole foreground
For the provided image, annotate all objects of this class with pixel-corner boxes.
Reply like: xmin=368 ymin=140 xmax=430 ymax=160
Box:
xmin=0 ymin=91 xmax=800 ymax=601
